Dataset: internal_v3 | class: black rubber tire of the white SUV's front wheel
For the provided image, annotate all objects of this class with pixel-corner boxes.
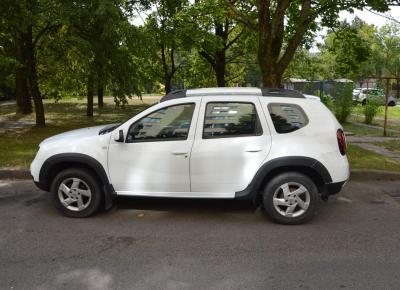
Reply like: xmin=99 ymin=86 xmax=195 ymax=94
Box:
xmin=51 ymin=168 xmax=103 ymax=218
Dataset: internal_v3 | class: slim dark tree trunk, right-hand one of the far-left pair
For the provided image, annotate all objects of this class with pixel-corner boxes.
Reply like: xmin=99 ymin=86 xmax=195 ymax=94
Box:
xmin=26 ymin=25 xmax=46 ymax=127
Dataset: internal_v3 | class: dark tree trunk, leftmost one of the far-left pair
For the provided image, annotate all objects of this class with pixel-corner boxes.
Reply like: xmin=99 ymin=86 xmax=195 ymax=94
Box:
xmin=15 ymin=31 xmax=32 ymax=114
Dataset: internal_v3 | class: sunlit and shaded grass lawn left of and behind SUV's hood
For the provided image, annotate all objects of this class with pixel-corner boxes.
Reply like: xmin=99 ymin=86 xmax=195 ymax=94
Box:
xmin=0 ymin=98 xmax=158 ymax=168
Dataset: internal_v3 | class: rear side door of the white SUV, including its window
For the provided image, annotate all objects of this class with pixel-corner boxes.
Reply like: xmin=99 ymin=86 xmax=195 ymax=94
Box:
xmin=190 ymin=96 xmax=271 ymax=198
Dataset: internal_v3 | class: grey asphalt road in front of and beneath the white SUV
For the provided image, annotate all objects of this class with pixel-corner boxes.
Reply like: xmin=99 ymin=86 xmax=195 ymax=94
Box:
xmin=0 ymin=181 xmax=400 ymax=290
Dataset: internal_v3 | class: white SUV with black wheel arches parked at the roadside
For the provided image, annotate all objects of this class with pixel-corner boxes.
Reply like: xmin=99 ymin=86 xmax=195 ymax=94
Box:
xmin=31 ymin=88 xmax=349 ymax=224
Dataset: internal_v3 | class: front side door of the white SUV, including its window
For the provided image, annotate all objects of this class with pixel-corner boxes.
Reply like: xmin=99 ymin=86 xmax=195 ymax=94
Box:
xmin=108 ymin=100 xmax=200 ymax=196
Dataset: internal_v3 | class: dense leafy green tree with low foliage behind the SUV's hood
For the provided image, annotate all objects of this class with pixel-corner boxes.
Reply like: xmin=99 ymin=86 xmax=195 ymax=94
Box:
xmin=65 ymin=0 xmax=147 ymax=117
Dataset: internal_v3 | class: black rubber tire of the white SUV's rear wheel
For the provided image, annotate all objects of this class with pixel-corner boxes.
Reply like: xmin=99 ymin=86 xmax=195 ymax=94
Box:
xmin=262 ymin=172 xmax=320 ymax=225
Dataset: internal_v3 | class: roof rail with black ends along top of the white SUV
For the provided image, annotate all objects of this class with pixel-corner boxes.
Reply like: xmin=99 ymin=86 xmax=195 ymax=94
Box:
xmin=160 ymin=88 xmax=305 ymax=103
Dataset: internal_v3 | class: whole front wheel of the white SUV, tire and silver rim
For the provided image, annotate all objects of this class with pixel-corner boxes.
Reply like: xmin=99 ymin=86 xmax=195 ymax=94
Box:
xmin=51 ymin=168 xmax=102 ymax=218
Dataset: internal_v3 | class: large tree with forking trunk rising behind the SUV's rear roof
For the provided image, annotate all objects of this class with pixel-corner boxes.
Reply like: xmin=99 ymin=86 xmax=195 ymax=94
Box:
xmin=226 ymin=0 xmax=395 ymax=87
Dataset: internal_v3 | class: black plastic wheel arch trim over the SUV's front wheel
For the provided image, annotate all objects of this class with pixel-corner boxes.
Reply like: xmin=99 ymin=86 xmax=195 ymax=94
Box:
xmin=35 ymin=153 xmax=115 ymax=209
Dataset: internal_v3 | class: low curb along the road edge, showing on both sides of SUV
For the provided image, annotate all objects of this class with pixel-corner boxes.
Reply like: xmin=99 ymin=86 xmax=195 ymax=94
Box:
xmin=0 ymin=168 xmax=400 ymax=181
